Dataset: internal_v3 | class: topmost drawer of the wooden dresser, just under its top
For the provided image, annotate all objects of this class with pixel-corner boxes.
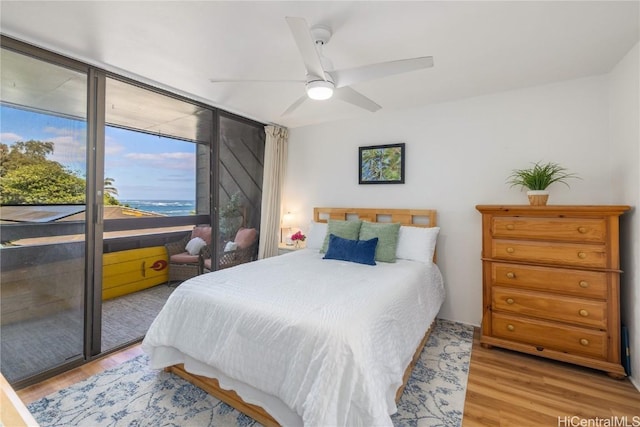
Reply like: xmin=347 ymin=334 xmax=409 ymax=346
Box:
xmin=491 ymin=216 xmax=607 ymax=243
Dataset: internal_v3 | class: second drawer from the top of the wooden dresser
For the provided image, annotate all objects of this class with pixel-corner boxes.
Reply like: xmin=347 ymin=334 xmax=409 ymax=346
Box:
xmin=491 ymin=239 xmax=608 ymax=268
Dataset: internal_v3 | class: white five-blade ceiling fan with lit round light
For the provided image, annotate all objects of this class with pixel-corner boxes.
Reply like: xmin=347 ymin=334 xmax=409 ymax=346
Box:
xmin=211 ymin=16 xmax=433 ymax=116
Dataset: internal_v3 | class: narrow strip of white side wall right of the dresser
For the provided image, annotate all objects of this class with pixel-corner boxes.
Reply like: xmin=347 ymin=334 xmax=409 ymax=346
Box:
xmin=609 ymin=44 xmax=640 ymax=390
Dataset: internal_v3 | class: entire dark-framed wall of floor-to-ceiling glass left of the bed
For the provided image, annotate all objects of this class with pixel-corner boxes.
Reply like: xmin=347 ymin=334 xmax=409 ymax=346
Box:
xmin=0 ymin=37 xmax=264 ymax=388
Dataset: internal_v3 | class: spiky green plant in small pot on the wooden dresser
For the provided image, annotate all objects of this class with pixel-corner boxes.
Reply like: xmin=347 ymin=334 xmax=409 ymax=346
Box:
xmin=507 ymin=162 xmax=578 ymax=206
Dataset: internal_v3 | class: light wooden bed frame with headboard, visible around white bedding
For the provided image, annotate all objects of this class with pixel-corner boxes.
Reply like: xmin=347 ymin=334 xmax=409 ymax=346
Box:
xmin=165 ymin=208 xmax=437 ymax=427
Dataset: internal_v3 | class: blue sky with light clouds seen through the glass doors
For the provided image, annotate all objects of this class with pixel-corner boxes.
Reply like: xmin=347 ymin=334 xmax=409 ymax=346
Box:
xmin=0 ymin=105 xmax=196 ymax=200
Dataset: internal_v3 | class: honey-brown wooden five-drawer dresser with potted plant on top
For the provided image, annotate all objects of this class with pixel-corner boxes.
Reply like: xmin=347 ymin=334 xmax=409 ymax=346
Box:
xmin=476 ymin=205 xmax=629 ymax=378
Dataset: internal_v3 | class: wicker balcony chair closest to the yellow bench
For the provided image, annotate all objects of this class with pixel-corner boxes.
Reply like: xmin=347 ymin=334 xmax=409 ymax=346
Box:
xmin=164 ymin=225 xmax=211 ymax=282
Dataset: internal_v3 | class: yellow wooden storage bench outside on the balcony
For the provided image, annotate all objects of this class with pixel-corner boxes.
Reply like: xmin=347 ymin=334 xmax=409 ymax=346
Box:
xmin=102 ymin=246 xmax=169 ymax=300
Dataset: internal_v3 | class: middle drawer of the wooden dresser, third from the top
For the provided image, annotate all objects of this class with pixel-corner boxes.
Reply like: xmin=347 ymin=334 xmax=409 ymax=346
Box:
xmin=491 ymin=262 xmax=607 ymax=300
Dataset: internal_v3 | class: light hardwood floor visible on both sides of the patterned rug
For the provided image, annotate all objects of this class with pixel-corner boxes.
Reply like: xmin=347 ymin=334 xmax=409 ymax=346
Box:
xmin=17 ymin=330 xmax=640 ymax=427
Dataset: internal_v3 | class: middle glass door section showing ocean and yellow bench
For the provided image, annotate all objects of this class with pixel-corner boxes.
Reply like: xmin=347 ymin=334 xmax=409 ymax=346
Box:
xmin=101 ymin=77 xmax=215 ymax=351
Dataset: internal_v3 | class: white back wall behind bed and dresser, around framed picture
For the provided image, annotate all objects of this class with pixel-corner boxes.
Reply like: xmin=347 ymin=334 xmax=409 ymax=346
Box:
xmin=283 ymin=76 xmax=616 ymax=325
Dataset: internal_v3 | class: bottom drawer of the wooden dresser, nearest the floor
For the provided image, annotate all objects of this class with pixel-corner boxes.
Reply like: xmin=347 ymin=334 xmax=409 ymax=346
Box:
xmin=491 ymin=313 xmax=607 ymax=359
